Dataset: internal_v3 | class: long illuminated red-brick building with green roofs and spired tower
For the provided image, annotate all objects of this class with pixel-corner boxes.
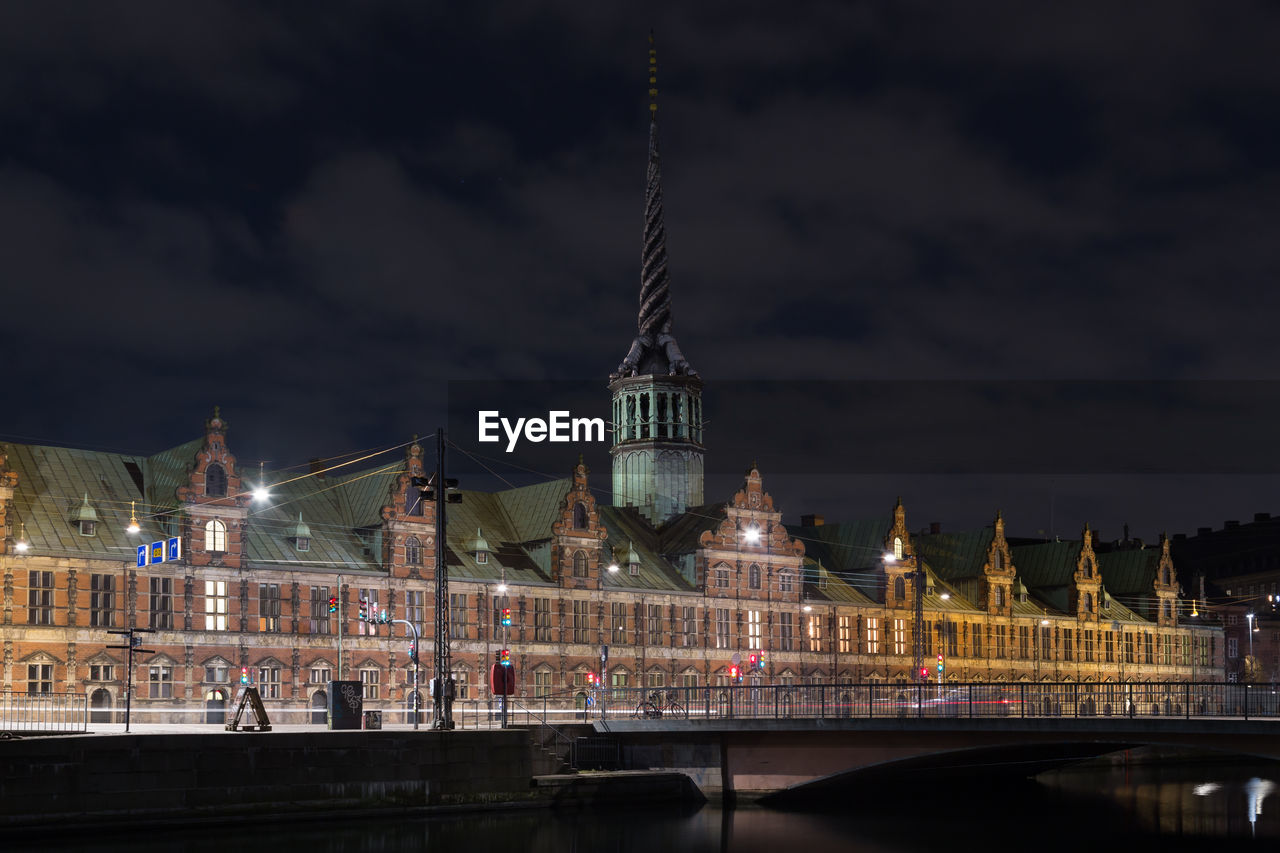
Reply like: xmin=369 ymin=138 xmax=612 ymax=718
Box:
xmin=0 ymin=53 xmax=1222 ymax=721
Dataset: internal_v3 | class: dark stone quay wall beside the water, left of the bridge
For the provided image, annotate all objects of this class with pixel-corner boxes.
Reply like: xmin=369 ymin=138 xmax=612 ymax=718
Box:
xmin=0 ymin=729 xmax=538 ymax=829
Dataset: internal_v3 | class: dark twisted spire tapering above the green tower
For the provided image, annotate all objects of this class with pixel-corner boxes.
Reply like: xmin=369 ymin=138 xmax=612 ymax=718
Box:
xmin=611 ymin=32 xmax=698 ymax=379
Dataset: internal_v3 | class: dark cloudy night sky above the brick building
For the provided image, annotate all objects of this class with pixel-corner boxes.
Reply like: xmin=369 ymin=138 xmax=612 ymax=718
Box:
xmin=0 ymin=0 xmax=1280 ymax=540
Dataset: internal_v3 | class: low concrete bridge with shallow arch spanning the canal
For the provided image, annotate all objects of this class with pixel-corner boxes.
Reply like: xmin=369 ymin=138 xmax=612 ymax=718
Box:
xmin=594 ymin=717 xmax=1280 ymax=807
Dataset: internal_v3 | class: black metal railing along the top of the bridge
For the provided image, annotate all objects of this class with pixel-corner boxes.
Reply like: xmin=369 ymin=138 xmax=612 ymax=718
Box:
xmin=590 ymin=681 xmax=1280 ymax=720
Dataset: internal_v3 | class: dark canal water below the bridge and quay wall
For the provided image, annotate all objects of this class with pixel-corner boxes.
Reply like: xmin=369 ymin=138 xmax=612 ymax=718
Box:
xmin=20 ymin=751 xmax=1280 ymax=853
